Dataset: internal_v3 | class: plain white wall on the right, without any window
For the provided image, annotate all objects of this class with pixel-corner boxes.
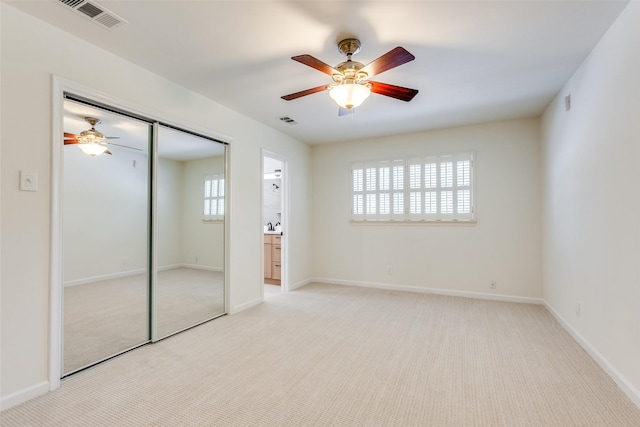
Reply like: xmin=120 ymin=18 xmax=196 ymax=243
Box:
xmin=542 ymin=2 xmax=640 ymax=405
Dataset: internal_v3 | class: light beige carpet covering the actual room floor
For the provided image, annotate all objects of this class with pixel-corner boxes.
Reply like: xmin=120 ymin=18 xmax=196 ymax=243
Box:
xmin=0 ymin=284 xmax=640 ymax=427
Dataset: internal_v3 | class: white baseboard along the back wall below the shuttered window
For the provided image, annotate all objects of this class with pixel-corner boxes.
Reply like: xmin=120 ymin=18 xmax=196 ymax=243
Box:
xmin=309 ymin=277 xmax=543 ymax=304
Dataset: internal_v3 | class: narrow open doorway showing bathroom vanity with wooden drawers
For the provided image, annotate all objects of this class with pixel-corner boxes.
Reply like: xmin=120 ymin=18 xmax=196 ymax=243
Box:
xmin=262 ymin=151 xmax=289 ymax=296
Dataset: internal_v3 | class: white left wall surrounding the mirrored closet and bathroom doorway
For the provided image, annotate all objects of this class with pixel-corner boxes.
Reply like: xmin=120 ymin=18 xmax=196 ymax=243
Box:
xmin=0 ymin=3 xmax=310 ymax=406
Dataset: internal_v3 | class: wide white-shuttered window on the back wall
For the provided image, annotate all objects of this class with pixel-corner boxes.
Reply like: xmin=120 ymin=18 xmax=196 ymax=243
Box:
xmin=351 ymin=153 xmax=475 ymax=221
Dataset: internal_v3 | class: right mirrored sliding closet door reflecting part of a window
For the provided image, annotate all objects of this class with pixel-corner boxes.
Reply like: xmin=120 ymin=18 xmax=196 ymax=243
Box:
xmin=154 ymin=125 xmax=225 ymax=339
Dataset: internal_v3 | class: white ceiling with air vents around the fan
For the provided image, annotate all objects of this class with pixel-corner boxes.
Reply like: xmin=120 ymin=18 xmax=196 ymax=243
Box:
xmin=8 ymin=0 xmax=627 ymax=144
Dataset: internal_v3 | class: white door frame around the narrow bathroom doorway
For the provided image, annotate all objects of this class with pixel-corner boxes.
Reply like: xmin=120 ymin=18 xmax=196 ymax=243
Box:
xmin=260 ymin=148 xmax=290 ymax=294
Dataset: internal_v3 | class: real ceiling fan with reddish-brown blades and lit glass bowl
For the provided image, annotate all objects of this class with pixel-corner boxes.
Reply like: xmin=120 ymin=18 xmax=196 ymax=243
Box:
xmin=282 ymin=38 xmax=418 ymax=116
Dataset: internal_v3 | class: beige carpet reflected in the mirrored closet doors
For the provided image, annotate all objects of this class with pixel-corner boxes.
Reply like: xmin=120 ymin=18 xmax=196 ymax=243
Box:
xmin=63 ymin=267 xmax=224 ymax=373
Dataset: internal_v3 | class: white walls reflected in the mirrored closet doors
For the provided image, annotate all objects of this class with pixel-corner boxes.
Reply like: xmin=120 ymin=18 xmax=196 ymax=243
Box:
xmin=63 ymin=146 xmax=224 ymax=285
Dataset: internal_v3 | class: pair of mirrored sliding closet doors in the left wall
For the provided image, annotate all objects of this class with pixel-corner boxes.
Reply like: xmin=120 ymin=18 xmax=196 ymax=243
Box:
xmin=60 ymin=94 xmax=227 ymax=377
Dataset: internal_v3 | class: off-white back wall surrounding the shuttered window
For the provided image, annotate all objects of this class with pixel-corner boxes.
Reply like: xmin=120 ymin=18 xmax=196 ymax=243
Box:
xmin=313 ymin=119 xmax=542 ymax=298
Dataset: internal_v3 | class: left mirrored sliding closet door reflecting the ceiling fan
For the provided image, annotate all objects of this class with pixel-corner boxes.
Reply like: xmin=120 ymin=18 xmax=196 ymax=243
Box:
xmin=62 ymin=100 xmax=151 ymax=374
